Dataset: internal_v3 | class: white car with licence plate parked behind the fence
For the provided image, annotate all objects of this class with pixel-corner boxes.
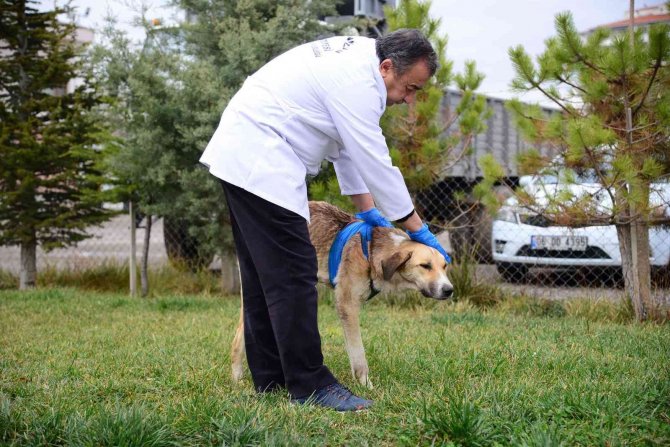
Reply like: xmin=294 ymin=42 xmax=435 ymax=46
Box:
xmin=491 ymin=173 xmax=670 ymax=282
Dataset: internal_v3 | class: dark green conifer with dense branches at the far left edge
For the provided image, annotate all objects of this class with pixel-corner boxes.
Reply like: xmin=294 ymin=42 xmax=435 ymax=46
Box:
xmin=0 ymin=0 xmax=110 ymax=288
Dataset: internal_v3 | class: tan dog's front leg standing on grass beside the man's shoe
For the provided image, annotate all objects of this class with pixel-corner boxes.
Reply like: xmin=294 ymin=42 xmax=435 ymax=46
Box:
xmin=335 ymin=284 xmax=372 ymax=388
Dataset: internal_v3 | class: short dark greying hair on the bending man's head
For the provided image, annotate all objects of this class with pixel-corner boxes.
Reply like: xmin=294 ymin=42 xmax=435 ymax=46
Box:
xmin=375 ymin=28 xmax=438 ymax=76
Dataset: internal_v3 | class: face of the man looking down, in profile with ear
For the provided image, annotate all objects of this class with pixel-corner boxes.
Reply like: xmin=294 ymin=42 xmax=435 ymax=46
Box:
xmin=379 ymin=59 xmax=430 ymax=106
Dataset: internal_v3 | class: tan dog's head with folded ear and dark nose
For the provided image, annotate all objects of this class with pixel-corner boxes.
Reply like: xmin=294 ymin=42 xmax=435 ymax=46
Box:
xmin=381 ymin=241 xmax=454 ymax=300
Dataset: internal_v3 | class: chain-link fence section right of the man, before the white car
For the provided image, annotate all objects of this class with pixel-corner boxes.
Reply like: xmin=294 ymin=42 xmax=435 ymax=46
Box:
xmin=416 ymin=180 xmax=670 ymax=302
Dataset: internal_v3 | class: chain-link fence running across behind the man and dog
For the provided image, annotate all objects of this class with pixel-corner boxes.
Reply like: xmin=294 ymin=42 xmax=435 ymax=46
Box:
xmin=0 ymin=189 xmax=670 ymax=301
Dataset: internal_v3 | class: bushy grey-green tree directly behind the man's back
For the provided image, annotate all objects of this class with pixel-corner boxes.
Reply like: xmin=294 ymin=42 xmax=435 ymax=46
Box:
xmin=96 ymin=0 xmax=334 ymax=288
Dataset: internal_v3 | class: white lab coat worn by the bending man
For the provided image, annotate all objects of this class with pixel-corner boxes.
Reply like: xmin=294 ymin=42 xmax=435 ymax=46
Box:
xmin=200 ymin=36 xmax=413 ymax=221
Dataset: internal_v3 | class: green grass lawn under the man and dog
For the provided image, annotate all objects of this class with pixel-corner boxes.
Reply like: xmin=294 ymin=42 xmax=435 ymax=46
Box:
xmin=0 ymin=288 xmax=670 ymax=446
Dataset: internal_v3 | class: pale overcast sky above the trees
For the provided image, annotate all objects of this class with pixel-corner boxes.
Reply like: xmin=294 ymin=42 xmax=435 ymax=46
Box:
xmin=50 ymin=0 xmax=663 ymax=101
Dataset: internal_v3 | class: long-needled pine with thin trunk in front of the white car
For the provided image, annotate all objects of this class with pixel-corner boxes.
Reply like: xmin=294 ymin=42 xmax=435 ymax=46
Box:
xmin=510 ymin=13 xmax=670 ymax=320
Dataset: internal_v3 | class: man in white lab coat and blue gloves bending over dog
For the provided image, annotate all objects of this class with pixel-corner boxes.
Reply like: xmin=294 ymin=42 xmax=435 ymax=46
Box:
xmin=200 ymin=29 xmax=449 ymax=411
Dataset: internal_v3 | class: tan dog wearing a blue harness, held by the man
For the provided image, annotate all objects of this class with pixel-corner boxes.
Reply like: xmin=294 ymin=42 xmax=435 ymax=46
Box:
xmin=232 ymin=202 xmax=453 ymax=388
